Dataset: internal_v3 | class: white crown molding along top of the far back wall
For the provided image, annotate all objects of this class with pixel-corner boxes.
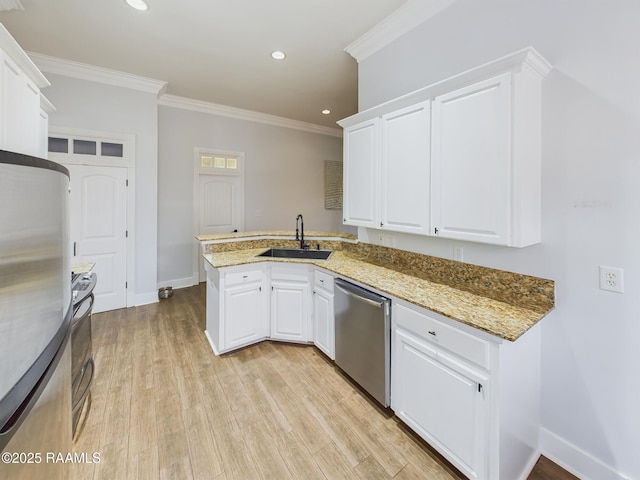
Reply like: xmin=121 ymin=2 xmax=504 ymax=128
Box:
xmin=158 ymin=95 xmax=342 ymax=137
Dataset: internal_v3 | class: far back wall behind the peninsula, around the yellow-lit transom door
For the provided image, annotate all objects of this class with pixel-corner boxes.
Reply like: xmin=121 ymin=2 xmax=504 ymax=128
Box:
xmin=158 ymin=106 xmax=344 ymax=286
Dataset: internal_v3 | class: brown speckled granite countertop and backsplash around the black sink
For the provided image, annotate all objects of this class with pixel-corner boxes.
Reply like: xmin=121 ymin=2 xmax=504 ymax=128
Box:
xmin=203 ymin=234 xmax=554 ymax=341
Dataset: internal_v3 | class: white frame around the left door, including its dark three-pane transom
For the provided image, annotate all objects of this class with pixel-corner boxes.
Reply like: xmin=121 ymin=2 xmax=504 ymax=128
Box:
xmin=47 ymin=126 xmax=136 ymax=307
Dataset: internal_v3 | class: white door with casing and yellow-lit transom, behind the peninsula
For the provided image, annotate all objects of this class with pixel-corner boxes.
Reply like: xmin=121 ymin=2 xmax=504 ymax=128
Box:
xmin=193 ymin=148 xmax=244 ymax=285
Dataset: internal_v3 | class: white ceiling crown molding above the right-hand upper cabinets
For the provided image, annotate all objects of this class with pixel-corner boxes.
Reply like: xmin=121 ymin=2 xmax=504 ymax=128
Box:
xmin=344 ymin=0 xmax=456 ymax=63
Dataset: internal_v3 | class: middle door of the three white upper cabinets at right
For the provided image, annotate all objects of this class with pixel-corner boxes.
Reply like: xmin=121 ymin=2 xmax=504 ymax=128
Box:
xmin=380 ymin=101 xmax=431 ymax=235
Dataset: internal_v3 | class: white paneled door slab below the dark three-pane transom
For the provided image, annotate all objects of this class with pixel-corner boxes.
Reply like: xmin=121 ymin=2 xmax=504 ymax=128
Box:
xmin=66 ymin=165 xmax=127 ymax=312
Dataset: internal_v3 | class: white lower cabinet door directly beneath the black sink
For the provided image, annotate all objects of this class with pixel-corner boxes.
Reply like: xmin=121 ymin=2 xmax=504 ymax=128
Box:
xmin=271 ymin=274 xmax=311 ymax=342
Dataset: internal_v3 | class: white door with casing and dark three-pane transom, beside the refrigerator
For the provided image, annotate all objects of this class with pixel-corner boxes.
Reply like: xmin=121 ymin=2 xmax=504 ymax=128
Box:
xmin=48 ymin=126 xmax=136 ymax=312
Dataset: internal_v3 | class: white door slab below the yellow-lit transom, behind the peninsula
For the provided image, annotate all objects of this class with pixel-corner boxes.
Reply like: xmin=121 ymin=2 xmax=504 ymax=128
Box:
xmin=198 ymin=174 xmax=244 ymax=282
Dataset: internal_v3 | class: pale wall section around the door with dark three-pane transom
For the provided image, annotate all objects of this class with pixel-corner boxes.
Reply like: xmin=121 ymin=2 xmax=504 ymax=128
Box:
xmin=44 ymin=73 xmax=158 ymax=304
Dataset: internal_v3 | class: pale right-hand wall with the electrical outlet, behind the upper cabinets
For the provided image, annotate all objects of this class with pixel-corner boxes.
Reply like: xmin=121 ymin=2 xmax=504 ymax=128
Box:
xmin=359 ymin=0 xmax=640 ymax=479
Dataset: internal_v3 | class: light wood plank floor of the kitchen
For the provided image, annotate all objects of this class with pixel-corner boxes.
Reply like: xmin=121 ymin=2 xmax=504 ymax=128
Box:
xmin=71 ymin=284 xmax=575 ymax=480
